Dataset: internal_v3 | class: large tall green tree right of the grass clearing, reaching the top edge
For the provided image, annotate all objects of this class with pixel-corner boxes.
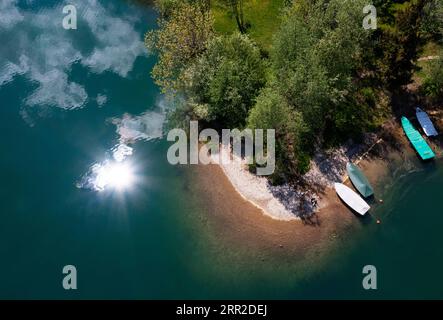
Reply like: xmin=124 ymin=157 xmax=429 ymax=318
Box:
xmin=272 ymin=0 xmax=371 ymax=145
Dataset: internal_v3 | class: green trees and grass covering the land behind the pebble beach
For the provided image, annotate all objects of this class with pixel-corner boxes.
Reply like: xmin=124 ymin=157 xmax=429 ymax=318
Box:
xmin=145 ymin=0 xmax=443 ymax=184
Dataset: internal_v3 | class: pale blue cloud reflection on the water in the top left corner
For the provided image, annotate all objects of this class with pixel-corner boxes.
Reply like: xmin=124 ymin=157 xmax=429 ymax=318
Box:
xmin=0 ymin=0 xmax=146 ymax=110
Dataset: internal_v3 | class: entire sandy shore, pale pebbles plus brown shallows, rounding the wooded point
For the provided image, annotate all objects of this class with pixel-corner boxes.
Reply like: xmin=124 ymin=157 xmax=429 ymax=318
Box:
xmin=194 ymin=112 xmax=441 ymax=258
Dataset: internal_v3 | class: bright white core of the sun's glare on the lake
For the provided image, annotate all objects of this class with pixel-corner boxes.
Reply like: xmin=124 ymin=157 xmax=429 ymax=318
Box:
xmin=94 ymin=162 xmax=134 ymax=191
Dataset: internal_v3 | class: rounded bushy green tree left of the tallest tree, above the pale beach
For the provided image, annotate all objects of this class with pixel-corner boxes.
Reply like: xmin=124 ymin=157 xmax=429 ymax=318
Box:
xmin=184 ymin=33 xmax=266 ymax=128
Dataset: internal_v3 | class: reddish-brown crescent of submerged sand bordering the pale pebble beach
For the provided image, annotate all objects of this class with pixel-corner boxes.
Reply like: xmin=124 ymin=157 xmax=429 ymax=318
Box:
xmin=196 ymin=165 xmax=355 ymax=256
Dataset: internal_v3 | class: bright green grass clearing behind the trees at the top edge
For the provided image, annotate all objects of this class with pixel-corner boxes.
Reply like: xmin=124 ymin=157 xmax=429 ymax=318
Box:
xmin=211 ymin=0 xmax=285 ymax=51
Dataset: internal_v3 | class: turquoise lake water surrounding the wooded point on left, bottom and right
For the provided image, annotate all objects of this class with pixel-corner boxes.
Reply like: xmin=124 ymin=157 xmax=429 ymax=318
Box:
xmin=0 ymin=0 xmax=443 ymax=299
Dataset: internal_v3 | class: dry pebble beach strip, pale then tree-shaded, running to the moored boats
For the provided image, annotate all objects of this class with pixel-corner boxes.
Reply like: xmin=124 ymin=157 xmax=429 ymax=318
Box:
xmin=211 ymin=112 xmax=442 ymax=221
